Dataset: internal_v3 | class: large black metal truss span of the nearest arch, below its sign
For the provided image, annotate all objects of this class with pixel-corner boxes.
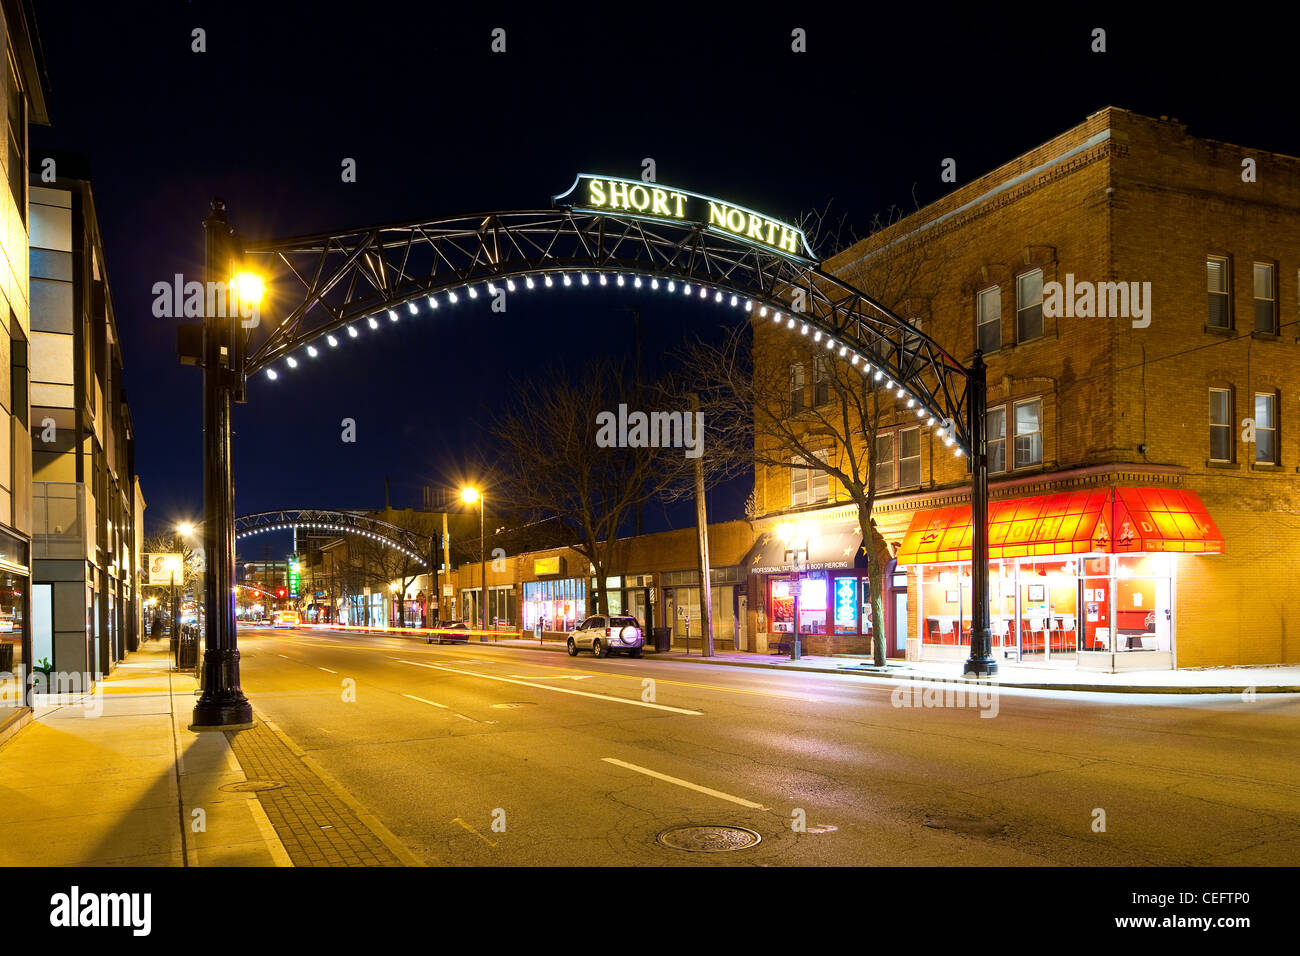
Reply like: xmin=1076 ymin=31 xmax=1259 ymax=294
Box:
xmin=244 ymin=208 xmax=971 ymax=454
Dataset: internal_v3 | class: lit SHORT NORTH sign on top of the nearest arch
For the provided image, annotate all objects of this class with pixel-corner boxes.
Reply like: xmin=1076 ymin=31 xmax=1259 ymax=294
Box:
xmin=555 ymin=173 xmax=815 ymax=260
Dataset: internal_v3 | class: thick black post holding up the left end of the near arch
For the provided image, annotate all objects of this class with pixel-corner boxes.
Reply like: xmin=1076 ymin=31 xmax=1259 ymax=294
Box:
xmin=192 ymin=199 xmax=252 ymax=730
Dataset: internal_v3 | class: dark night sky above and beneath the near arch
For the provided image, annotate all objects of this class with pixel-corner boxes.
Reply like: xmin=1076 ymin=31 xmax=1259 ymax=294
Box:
xmin=22 ymin=0 xmax=1300 ymax=548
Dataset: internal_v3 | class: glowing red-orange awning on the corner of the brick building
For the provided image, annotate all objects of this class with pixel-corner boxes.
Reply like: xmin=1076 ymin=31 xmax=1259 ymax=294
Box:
xmin=898 ymin=488 xmax=1223 ymax=564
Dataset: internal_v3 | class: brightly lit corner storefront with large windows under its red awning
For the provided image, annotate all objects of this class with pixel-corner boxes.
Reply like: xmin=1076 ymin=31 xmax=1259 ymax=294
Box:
xmin=898 ymin=488 xmax=1223 ymax=671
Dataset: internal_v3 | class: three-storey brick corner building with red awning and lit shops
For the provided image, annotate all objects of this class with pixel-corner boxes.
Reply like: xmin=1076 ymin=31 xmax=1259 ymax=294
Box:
xmin=749 ymin=108 xmax=1300 ymax=670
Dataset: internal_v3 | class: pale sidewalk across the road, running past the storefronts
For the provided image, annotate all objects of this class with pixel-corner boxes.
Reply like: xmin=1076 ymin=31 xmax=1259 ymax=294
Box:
xmin=353 ymin=628 xmax=1300 ymax=695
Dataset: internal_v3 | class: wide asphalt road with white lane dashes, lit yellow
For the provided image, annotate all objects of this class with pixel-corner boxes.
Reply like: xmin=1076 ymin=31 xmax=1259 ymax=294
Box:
xmin=233 ymin=628 xmax=1300 ymax=866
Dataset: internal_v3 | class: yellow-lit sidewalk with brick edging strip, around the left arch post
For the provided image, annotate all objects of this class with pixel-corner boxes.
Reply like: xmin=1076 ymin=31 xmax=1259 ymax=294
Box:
xmin=0 ymin=641 xmax=420 ymax=866
